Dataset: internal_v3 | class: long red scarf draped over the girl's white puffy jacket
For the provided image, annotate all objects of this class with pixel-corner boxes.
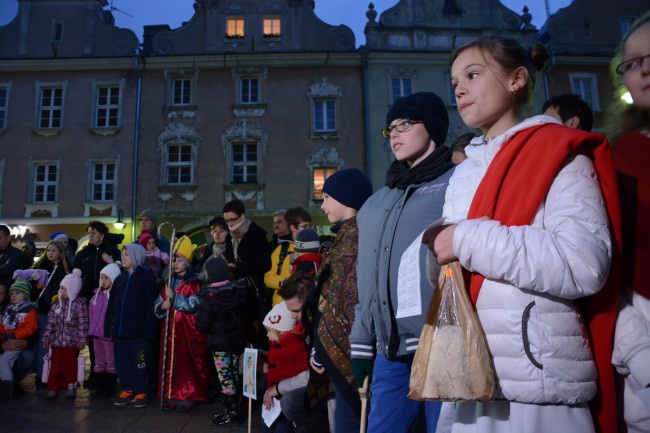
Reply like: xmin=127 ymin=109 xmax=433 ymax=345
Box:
xmin=467 ymin=124 xmax=622 ymax=433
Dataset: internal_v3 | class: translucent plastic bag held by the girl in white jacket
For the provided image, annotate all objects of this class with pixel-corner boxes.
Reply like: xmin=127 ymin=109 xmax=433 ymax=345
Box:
xmin=408 ymin=262 xmax=496 ymax=401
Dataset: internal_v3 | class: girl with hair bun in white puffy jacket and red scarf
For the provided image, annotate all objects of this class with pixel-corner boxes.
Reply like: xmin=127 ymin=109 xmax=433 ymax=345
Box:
xmin=429 ymin=37 xmax=620 ymax=433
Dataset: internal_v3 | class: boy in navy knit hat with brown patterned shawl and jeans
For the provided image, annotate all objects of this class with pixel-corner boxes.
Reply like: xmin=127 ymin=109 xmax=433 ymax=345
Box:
xmin=310 ymin=168 xmax=372 ymax=431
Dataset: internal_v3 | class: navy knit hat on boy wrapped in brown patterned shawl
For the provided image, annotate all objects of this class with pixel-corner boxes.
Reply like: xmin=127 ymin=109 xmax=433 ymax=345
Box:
xmin=323 ymin=168 xmax=372 ymax=210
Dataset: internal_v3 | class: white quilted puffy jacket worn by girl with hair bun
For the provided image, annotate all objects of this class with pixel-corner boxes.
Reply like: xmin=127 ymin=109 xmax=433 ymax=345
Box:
xmin=443 ymin=116 xmax=611 ymax=404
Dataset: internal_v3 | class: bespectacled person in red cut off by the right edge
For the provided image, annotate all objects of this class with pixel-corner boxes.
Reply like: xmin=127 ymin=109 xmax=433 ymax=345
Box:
xmin=608 ymin=11 xmax=650 ymax=433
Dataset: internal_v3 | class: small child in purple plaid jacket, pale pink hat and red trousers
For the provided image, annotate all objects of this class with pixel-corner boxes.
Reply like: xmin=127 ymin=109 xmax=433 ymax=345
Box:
xmin=43 ymin=268 xmax=88 ymax=400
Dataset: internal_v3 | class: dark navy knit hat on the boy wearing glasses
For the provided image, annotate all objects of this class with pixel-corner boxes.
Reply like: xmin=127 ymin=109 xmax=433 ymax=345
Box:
xmin=386 ymin=92 xmax=449 ymax=146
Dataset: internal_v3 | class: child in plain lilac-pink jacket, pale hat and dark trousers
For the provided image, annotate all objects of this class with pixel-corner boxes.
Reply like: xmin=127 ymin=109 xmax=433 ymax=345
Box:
xmin=88 ymin=262 xmax=122 ymax=397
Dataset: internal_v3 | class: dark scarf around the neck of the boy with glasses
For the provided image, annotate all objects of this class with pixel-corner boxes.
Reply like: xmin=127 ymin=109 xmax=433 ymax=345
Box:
xmin=386 ymin=146 xmax=454 ymax=189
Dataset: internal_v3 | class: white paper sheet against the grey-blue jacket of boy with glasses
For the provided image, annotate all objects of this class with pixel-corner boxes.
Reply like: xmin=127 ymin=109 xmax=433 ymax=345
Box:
xmin=395 ymin=232 xmax=424 ymax=319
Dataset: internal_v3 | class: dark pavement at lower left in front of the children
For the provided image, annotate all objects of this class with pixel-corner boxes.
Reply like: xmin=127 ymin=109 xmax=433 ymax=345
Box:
xmin=0 ymin=375 xmax=262 ymax=433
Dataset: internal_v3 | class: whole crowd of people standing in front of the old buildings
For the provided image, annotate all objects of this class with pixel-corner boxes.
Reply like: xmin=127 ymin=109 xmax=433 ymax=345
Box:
xmin=0 ymin=12 xmax=650 ymax=433
